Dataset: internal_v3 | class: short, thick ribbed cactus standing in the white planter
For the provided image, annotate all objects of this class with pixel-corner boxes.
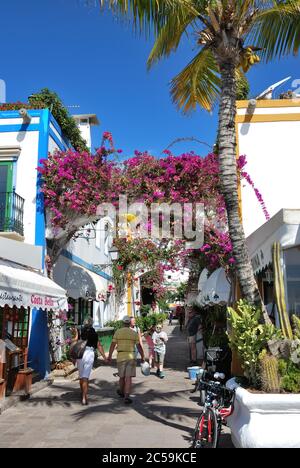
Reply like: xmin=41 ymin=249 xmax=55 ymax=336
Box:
xmin=259 ymin=350 xmax=280 ymax=393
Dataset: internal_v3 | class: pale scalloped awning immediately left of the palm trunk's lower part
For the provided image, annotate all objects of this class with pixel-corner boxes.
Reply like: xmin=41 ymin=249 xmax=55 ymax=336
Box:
xmin=197 ymin=268 xmax=230 ymax=306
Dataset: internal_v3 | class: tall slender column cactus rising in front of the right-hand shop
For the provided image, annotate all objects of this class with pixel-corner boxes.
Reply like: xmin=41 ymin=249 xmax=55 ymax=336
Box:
xmin=273 ymin=242 xmax=293 ymax=340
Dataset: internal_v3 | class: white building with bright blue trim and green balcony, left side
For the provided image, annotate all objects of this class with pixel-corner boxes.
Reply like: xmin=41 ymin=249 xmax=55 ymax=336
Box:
xmin=0 ymin=105 xmax=114 ymax=336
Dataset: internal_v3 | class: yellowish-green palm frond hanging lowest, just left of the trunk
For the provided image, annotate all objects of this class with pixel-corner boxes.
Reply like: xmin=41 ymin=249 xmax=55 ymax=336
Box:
xmin=171 ymin=48 xmax=220 ymax=113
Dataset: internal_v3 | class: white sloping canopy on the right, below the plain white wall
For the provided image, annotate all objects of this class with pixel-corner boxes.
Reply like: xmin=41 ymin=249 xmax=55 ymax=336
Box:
xmin=247 ymin=209 xmax=300 ymax=273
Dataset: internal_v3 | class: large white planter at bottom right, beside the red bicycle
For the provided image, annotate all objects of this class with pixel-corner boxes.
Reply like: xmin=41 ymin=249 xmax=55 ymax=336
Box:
xmin=226 ymin=379 xmax=300 ymax=448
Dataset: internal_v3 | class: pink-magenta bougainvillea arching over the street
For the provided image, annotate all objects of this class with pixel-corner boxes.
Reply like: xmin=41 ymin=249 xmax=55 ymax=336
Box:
xmin=38 ymin=132 xmax=269 ymax=280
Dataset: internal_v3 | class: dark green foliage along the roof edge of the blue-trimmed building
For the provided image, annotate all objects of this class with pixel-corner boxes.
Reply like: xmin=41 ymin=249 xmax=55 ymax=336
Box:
xmin=29 ymin=88 xmax=89 ymax=151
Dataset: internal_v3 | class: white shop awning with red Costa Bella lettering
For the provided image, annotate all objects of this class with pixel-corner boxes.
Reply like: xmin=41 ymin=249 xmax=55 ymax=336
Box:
xmin=0 ymin=260 xmax=68 ymax=310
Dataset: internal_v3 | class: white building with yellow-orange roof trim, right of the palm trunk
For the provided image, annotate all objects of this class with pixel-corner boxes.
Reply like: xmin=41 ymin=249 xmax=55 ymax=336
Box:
xmin=236 ymin=99 xmax=300 ymax=236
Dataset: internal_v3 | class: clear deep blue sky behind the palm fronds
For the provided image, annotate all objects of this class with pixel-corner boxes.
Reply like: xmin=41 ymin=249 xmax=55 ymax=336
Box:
xmin=0 ymin=0 xmax=300 ymax=156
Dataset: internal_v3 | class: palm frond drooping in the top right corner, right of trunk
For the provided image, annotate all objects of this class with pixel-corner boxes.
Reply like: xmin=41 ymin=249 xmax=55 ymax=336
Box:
xmin=251 ymin=0 xmax=300 ymax=61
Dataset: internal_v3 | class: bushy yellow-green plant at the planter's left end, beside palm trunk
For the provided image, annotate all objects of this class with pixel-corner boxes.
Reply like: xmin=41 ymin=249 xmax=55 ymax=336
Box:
xmin=227 ymin=300 xmax=282 ymax=387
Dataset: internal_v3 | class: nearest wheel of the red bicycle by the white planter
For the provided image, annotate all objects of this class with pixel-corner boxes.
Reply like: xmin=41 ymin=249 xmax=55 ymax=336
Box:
xmin=192 ymin=408 xmax=218 ymax=448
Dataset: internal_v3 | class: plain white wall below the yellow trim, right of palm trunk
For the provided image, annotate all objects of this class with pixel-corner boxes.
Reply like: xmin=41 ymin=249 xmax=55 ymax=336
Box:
xmin=238 ymin=108 xmax=300 ymax=236
